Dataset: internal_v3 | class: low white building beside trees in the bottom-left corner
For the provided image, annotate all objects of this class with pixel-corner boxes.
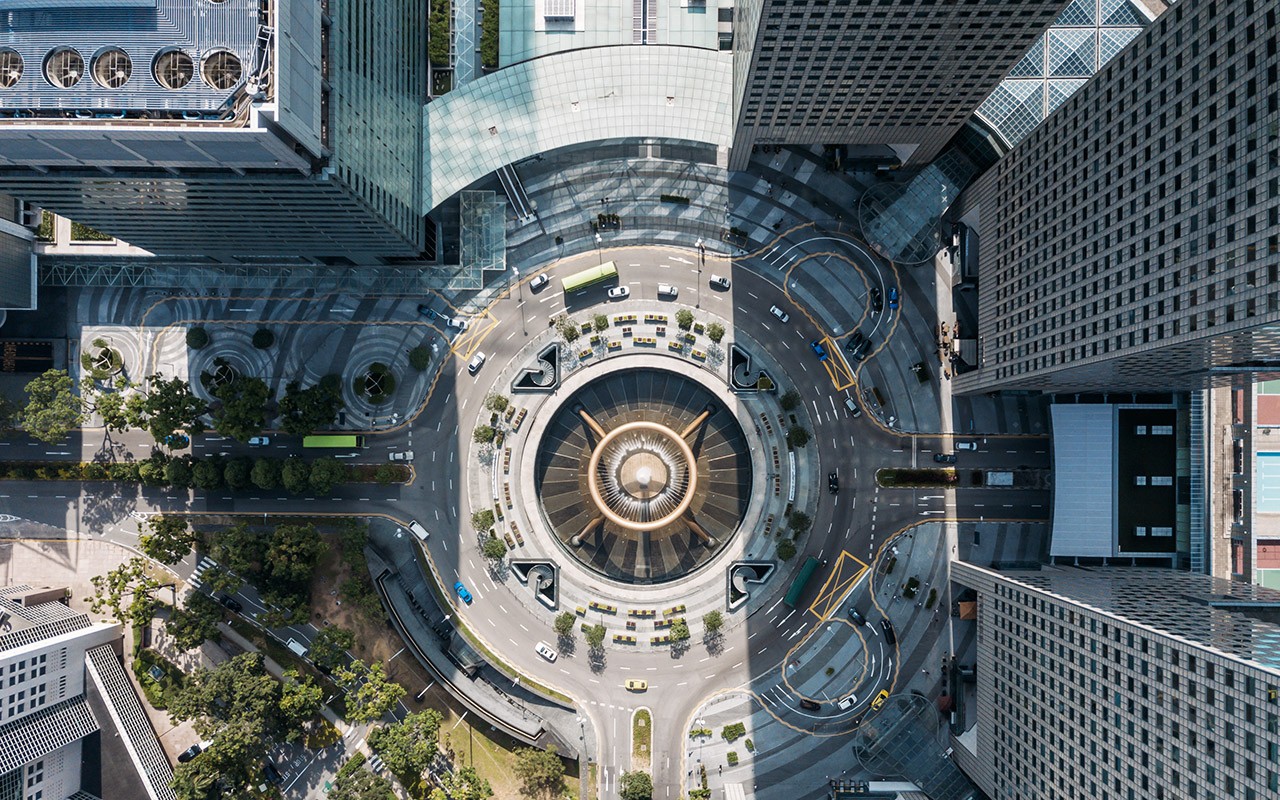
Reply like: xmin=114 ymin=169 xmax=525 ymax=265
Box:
xmin=0 ymin=585 xmax=174 ymax=800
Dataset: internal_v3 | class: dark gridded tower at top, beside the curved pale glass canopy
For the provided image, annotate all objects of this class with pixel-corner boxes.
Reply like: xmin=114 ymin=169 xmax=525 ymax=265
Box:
xmin=733 ymin=0 xmax=1066 ymax=168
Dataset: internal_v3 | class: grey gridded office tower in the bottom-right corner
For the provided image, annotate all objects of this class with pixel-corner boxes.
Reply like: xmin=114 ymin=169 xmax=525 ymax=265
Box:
xmin=951 ymin=562 xmax=1280 ymax=800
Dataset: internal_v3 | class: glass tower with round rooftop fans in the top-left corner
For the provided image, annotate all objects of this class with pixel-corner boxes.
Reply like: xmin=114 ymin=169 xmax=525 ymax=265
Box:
xmin=0 ymin=0 xmax=426 ymax=264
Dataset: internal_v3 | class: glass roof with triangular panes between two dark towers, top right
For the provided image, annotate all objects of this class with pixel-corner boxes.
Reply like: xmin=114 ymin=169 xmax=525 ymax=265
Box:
xmin=977 ymin=0 xmax=1152 ymax=146
